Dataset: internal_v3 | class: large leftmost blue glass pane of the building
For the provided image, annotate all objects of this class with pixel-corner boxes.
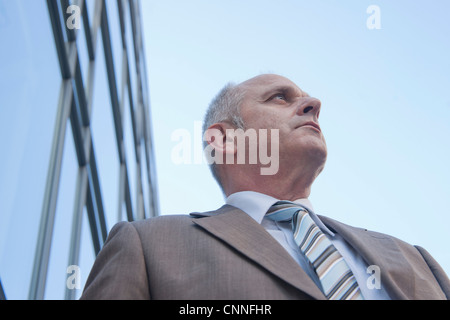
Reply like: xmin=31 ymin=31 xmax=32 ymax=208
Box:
xmin=0 ymin=0 xmax=61 ymax=299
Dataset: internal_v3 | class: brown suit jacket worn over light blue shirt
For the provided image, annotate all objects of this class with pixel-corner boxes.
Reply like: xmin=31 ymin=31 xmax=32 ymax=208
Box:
xmin=81 ymin=205 xmax=450 ymax=300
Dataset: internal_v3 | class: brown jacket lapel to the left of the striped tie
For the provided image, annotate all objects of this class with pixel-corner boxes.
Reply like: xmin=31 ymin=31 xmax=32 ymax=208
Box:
xmin=191 ymin=205 xmax=325 ymax=300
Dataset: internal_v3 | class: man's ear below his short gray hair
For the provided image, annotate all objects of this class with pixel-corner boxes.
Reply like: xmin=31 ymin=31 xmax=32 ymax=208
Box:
xmin=203 ymin=122 xmax=237 ymax=155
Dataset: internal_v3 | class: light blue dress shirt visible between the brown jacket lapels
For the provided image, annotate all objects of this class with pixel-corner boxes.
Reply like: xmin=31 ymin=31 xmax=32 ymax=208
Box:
xmin=226 ymin=191 xmax=390 ymax=300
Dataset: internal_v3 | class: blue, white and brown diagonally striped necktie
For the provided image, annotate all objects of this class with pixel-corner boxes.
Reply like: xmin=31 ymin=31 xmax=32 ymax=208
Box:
xmin=266 ymin=201 xmax=364 ymax=300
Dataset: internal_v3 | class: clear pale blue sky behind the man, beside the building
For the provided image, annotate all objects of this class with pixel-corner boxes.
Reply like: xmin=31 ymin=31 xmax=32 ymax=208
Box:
xmin=142 ymin=0 xmax=450 ymax=274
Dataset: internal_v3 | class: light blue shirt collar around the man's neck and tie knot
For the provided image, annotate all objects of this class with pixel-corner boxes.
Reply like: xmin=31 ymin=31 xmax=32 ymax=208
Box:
xmin=226 ymin=191 xmax=334 ymax=236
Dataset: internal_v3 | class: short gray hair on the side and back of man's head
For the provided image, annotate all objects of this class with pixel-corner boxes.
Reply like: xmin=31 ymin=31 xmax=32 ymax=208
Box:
xmin=203 ymin=82 xmax=244 ymax=191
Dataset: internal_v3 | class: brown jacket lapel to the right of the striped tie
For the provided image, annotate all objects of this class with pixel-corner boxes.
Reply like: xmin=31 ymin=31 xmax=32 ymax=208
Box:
xmin=320 ymin=216 xmax=415 ymax=299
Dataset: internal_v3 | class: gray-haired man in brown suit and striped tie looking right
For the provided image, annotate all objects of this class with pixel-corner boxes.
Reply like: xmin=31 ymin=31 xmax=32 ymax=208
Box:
xmin=82 ymin=74 xmax=450 ymax=300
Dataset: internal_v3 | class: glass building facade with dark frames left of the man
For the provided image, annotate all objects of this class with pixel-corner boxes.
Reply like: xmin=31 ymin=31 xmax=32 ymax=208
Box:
xmin=0 ymin=0 xmax=158 ymax=299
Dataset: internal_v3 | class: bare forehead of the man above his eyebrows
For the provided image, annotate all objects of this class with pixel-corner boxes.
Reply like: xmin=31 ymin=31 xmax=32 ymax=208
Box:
xmin=239 ymin=74 xmax=308 ymax=98
